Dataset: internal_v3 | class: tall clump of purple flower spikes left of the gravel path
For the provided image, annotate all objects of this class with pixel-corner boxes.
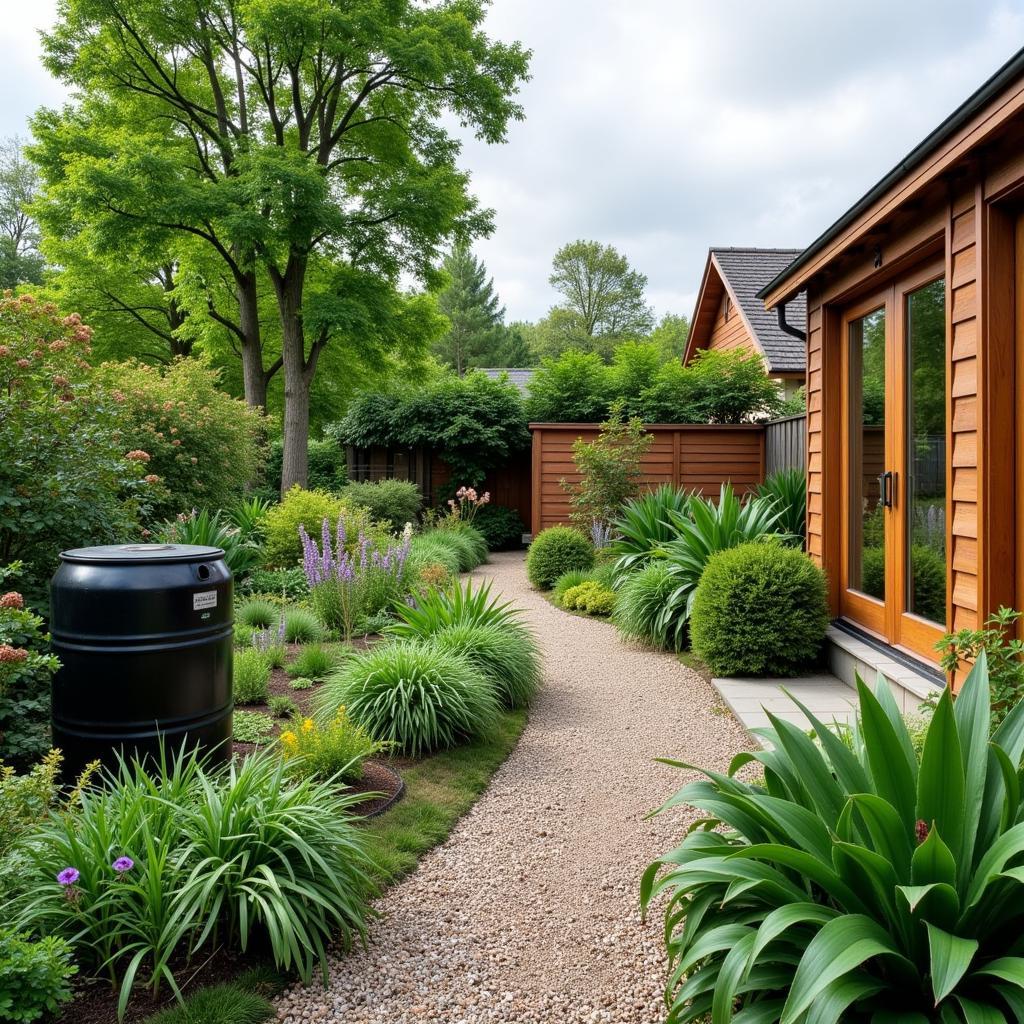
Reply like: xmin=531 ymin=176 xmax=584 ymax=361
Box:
xmin=299 ymin=518 xmax=412 ymax=640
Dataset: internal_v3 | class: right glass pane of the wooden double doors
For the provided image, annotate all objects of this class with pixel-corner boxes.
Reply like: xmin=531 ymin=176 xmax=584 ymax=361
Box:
xmin=903 ymin=279 xmax=948 ymax=627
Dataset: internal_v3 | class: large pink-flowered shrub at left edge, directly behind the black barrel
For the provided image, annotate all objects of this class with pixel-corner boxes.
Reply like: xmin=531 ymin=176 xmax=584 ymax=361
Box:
xmin=0 ymin=295 xmax=146 ymax=604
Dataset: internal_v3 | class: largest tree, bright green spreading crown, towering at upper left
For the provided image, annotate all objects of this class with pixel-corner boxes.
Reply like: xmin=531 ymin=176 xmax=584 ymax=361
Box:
xmin=37 ymin=0 xmax=528 ymax=488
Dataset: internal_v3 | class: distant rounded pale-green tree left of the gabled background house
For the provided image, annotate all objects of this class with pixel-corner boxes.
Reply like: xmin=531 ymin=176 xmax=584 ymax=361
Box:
xmin=548 ymin=240 xmax=653 ymax=356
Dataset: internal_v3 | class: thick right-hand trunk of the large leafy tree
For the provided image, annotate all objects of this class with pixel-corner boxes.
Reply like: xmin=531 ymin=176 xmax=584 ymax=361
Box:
xmin=271 ymin=255 xmax=317 ymax=494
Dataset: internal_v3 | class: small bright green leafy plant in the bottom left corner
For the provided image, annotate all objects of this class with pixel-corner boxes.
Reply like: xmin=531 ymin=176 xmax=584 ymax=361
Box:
xmin=0 ymin=928 xmax=78 ymax=1022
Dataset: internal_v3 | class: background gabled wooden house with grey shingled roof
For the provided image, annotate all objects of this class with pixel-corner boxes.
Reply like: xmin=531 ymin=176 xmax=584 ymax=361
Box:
xmin=683 ymin=248 xmax=807 ymax=398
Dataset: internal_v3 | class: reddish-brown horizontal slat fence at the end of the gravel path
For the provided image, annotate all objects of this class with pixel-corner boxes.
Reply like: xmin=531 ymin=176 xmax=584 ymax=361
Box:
xmin=529 ymin=423 xmax=765 ymax=535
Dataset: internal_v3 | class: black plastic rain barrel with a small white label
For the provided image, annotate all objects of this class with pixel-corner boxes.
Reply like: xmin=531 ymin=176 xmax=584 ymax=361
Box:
xmin=50 ymin=544 xmax=233 ymax=779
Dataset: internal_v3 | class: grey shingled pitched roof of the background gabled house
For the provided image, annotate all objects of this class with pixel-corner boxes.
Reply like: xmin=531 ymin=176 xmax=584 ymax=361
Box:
xmin=686 ymin=247 xmax=807 ymax=374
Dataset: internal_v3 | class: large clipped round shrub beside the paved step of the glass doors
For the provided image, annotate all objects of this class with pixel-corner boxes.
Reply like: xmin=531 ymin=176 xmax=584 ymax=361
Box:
xmin=690 ymin=544 xmax=828 ymax=676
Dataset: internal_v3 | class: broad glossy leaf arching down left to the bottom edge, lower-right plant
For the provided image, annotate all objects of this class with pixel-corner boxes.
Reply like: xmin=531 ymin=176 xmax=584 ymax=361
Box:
xmin=781 ymin=913 xmax=899 ymax=1024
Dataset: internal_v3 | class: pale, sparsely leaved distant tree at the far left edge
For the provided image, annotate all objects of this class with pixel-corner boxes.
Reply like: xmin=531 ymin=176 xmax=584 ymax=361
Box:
xmin=0 ymin=135 xmax=43 ymax=290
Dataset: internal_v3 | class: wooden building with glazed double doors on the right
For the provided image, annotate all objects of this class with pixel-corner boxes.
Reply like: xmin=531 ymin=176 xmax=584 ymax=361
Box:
xmin=760 ymin=50 xmax=1024 ymax=684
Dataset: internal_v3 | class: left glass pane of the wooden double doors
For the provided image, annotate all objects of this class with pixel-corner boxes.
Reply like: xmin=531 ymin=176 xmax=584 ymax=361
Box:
xmin=847 ymin=307 xmax=888 ymax=601
